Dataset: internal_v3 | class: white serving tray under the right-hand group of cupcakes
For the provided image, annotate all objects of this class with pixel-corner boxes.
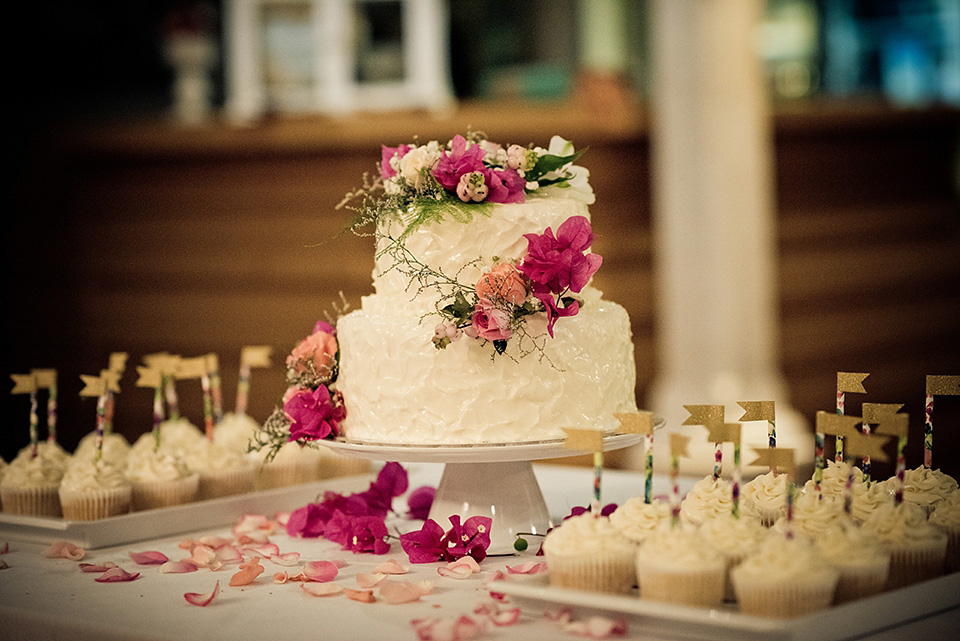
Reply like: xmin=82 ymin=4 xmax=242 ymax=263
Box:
xmin=491 ymin=572 xmax=960 ymax=641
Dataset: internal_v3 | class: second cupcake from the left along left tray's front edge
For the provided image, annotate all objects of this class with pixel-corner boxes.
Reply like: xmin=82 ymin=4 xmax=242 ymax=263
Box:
xmin=59 ymin=455 xmax=132 ymax=521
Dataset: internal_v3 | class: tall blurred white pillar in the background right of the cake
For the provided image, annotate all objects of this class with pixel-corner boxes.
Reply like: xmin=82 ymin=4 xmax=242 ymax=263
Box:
xmin=647 ymin=0 xmax=813 ymax=475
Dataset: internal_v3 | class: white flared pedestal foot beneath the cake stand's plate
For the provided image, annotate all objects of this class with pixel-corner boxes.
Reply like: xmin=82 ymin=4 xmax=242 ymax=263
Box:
xmin=430 ymin=461 xmax=551 ymax=555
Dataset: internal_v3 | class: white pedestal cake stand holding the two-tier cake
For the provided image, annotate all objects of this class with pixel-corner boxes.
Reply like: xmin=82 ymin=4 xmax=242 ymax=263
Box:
xmin=324 ymin=416 xmax=664 ymax=555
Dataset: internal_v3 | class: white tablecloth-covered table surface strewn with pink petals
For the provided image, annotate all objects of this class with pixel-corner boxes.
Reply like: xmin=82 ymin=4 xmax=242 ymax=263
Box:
xmin=0 ymin=463 xmax=960 ymax=641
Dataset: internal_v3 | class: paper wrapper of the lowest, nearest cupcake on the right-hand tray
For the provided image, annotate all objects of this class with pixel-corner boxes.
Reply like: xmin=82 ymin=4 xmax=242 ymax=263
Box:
xmin=732 ymin=568 xmax=838 ymax=619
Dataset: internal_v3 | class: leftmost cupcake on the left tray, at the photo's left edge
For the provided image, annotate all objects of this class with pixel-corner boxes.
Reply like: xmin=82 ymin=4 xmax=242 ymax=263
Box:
xmin=0 ymin=442 xmax=69 ymax=517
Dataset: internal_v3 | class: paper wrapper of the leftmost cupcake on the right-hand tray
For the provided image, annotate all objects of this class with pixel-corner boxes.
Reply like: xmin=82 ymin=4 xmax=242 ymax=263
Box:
xmin=545 ymin=550 xmax=637 ymax=594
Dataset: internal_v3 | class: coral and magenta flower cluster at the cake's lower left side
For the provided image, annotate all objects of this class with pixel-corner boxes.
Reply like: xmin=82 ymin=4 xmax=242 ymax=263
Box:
xmin=250 ymin=321 xmax=346 ymax=461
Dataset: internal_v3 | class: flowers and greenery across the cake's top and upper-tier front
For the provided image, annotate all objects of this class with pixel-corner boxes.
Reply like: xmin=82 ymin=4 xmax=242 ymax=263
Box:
xmin=340 ymin=133 xmax=602 ymax=354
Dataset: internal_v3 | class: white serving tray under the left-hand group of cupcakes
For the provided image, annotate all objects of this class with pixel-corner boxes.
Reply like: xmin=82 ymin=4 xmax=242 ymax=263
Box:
xmin=0 ymin=474 xmax=373 ymax=550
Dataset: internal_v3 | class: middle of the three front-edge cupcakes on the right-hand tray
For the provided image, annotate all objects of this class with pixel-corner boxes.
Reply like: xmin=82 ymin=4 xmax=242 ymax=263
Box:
xmin=636 ymin=517 xmax=728 ymax=608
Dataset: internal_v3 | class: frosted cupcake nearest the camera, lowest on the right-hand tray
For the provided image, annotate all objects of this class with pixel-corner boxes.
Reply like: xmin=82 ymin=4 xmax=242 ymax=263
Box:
xmin=731 ymin=535 xmax=840 ymax=618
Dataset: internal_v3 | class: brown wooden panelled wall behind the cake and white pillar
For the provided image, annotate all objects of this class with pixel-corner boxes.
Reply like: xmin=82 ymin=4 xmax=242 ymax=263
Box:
xmin=0 ymin=100 xmax=960 ymax=480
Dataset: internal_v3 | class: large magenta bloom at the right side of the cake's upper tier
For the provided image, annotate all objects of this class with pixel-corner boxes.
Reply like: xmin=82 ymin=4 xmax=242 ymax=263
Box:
xmin=519 ymin=216 xmax=603 ymax=294
